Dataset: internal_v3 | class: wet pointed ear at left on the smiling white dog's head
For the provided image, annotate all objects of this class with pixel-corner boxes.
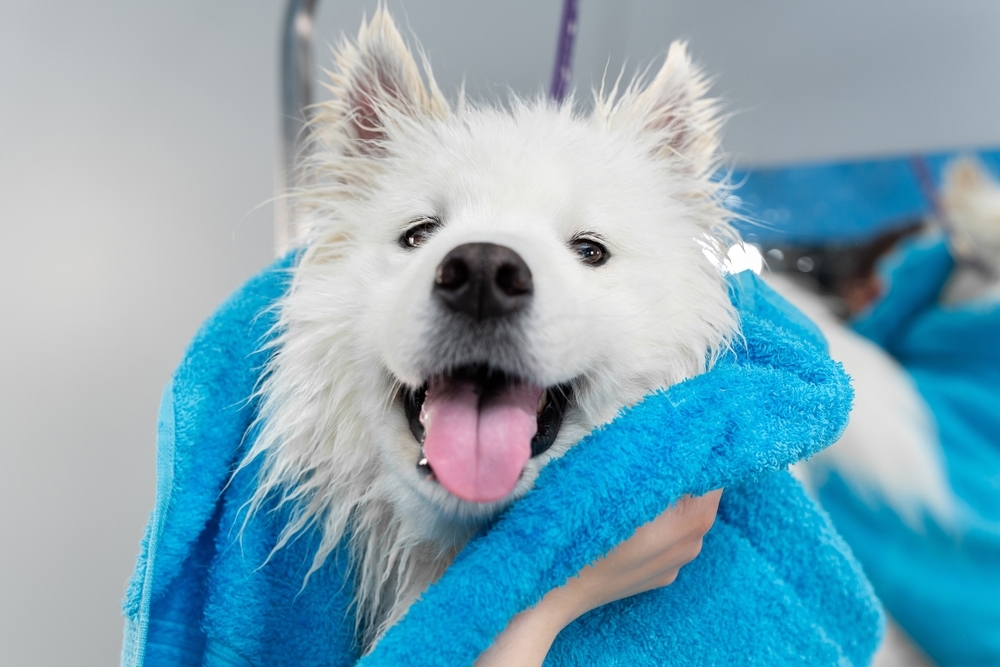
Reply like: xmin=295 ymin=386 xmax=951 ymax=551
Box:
xmin=317 ymin=7 xmax=448 ymax=156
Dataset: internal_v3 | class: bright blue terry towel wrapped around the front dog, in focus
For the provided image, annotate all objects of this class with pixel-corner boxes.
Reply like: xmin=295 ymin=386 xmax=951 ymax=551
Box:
xmin=122 ymin=259 xmax=882 ymax=667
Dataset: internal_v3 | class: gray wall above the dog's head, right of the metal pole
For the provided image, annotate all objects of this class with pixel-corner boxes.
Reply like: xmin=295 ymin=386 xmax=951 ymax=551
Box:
xmin=321 ymin=0 xmax=1000 ymax=164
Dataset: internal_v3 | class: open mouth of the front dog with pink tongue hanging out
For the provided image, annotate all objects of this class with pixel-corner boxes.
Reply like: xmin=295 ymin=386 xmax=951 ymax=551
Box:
xmin=403 ymin=365 xmax=571 ymax=503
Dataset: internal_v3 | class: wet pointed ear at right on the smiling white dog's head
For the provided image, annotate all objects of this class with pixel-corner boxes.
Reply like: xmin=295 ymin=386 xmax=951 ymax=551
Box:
xmin=599 ymin=42 xmax=721 ymax=175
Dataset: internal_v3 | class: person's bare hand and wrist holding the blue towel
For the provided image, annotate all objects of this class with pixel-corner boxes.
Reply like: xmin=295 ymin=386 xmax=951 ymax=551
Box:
xmin=476 ymin=489 xmax=722 ymax=667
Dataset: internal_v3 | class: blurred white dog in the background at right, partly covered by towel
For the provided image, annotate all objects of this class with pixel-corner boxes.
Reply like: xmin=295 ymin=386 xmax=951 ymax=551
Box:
xmin=767 ymin=158 xmax=1000 ymax=667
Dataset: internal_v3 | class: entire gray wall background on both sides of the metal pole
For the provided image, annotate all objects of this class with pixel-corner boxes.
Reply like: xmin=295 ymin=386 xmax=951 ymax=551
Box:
xmin=0 ymin=0 xmax=1000 ymax=665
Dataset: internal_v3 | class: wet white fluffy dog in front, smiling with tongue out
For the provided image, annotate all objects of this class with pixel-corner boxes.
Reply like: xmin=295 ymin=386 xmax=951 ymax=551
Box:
xmin=247 ymin=9 xmax=738 ymax=649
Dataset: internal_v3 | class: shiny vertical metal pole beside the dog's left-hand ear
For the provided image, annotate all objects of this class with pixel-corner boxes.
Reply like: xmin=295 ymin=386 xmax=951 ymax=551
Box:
xmin=274 ymin=0 xmax=317 ymax=256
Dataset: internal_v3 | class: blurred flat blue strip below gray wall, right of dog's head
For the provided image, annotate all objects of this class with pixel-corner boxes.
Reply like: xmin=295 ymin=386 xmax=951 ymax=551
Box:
xmin=730 ymin=149 xmax=1000 ymax=245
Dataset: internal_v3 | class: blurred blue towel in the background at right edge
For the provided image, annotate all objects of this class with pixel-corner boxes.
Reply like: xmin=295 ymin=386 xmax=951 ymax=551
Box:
xmin=820 ymin=239 xmax=1000 ymax=667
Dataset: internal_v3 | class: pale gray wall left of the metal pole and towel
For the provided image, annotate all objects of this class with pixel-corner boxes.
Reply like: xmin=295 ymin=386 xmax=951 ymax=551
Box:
xmin=0 ymin=0 xmax=280 ymax=667
